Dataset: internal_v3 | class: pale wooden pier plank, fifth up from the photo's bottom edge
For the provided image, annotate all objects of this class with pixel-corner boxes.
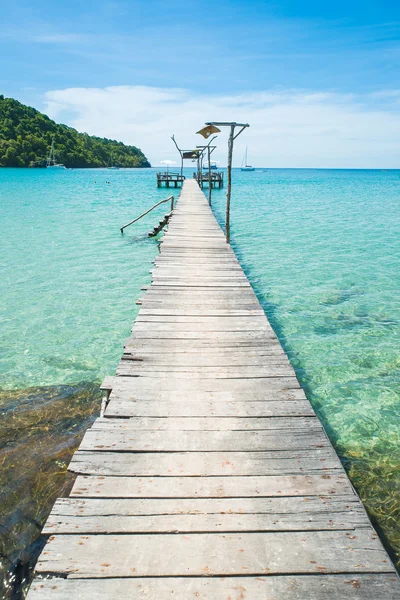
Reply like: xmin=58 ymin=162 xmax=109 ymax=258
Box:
xmin=70 ymin=474 xmax=352 ymax=498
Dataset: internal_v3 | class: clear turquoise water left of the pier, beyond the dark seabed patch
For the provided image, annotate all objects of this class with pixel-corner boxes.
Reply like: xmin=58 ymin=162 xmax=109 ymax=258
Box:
xmin=0 ymin=169 xmax=167 ymax=388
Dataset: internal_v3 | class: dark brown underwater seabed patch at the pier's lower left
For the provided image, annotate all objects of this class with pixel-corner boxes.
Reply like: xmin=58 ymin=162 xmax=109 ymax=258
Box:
xmin=0 ymin=382 xmax=101 ymax=600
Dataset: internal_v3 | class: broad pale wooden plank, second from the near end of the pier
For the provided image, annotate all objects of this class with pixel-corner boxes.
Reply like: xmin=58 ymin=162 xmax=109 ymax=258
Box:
xmin=36 ymin=529 xmax=394 ymax=578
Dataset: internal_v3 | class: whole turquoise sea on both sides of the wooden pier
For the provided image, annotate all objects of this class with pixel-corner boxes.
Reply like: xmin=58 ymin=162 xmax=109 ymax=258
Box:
xmin=0 ymin=168 xmax=400 ymax=598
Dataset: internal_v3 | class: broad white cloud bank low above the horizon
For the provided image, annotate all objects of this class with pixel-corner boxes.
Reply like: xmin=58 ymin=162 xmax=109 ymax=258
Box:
xmin=45 ymin=86 xmax=400 ymax=168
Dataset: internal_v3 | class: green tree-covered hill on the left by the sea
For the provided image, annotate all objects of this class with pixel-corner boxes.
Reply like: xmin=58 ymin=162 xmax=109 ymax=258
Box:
xmin=0 ymin=95 xmax=151 ymax=168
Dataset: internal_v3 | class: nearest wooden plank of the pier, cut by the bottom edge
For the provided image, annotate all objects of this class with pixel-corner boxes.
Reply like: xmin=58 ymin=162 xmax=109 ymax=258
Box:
xmin=25 ymin=573 xmax=399 ymax=600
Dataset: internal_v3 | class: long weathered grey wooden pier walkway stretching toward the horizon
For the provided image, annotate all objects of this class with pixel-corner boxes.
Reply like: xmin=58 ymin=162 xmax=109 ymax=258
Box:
xmin=28 ymin=180 xmax=400 ymax=600
